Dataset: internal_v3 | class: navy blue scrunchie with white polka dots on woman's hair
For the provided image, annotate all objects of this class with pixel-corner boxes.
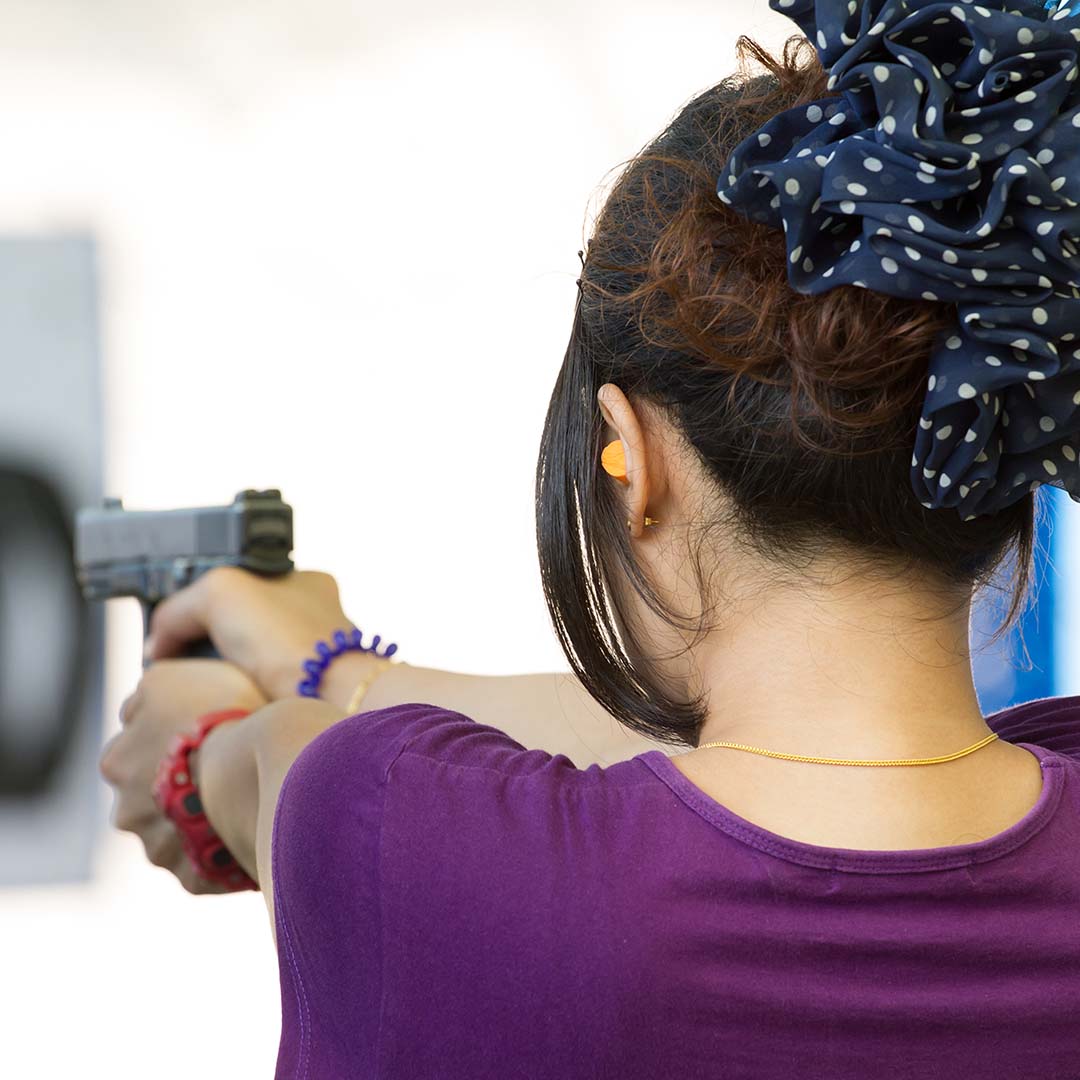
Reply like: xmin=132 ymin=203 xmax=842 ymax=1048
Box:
xmin=717 ymin=0 xmax=1080 ymax=521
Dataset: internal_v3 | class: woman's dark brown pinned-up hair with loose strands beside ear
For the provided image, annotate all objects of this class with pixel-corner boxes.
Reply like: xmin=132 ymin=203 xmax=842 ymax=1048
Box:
xmin=536 ymin=37 xmax=1036 ymax=746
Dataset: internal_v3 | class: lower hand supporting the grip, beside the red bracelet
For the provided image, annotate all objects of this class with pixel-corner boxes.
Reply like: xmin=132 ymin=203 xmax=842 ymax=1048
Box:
xmin=98 ymin=660 xmax=266 ymax=893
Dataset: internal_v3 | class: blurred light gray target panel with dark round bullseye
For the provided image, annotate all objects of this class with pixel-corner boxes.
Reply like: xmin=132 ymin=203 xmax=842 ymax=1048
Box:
xmin=0 ymin=235 xmax=104 ymax=885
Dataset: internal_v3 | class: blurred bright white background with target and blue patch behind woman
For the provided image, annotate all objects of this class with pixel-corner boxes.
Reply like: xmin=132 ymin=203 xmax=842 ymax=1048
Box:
xmin=0 ymin=0 xmax=1080 ymax=1080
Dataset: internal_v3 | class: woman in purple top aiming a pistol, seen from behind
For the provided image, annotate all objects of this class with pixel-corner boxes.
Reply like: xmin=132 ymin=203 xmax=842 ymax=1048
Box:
xmin=102 ymin=0 xmax=1080 ymax=1080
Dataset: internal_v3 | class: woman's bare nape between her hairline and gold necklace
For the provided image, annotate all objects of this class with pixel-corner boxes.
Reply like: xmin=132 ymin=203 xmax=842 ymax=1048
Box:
xmin=694 ymin=574 xmax=991 ymax=771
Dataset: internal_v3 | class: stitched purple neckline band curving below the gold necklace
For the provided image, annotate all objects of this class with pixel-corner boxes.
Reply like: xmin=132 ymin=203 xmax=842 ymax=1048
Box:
xmin=638 ymin=742 xmax=1065 ymax=874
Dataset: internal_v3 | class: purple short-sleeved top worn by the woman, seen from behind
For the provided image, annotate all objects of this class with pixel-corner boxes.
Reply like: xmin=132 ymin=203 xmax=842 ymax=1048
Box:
xmin=272 ymin=696 xmax=1080 ymax=1080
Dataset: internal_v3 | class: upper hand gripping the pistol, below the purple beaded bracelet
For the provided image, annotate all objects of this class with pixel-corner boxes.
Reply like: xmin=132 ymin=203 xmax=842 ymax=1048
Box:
xmin=146 ymin=566 xmax=353 ymax=700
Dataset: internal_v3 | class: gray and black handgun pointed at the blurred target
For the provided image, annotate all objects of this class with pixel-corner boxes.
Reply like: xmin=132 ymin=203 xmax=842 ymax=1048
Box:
xmin=75 ymin=488 xmax=293 ymax=666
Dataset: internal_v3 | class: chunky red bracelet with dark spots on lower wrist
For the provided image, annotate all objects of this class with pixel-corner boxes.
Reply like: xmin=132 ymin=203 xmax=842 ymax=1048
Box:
xmin=153 ymin=708 xmax=258 ymax=892
